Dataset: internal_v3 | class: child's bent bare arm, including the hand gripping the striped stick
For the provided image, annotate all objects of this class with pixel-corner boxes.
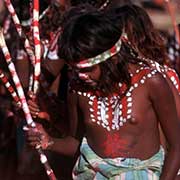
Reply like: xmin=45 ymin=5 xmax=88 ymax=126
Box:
xmin=28 ymin=90 xmax=79 ymax=156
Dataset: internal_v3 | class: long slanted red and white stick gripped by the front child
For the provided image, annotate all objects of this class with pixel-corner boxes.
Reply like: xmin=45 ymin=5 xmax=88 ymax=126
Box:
xmin=0 ymin=29 xmax=56 ymax=180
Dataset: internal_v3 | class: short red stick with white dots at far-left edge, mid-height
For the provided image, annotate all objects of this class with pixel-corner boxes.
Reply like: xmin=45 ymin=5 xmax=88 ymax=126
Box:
xmin=0 ymin=69 xmax=21 ymax=108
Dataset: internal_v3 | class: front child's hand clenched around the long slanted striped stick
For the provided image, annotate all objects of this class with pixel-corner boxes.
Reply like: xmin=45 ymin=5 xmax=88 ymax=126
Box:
xmin=23 ymin=123 xmax=54 ymax=150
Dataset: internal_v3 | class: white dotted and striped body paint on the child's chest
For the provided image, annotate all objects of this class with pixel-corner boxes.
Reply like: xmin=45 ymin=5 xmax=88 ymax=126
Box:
xmin=77 ymin=67 xmax=157 ymax=131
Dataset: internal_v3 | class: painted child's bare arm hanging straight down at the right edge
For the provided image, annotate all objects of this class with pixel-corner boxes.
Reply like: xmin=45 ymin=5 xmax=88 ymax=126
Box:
xmin=148 ymin=74 xmax=180 ymax=180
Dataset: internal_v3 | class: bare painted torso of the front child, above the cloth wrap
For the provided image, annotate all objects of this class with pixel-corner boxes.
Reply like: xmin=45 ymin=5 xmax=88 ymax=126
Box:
xmin=71 ymin=64 xmax=162 ymax=159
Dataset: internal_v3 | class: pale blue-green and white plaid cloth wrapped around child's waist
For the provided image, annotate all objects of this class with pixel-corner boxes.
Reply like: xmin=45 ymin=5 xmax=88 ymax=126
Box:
xmin=72 ymin=138 xmax=164 ymax=180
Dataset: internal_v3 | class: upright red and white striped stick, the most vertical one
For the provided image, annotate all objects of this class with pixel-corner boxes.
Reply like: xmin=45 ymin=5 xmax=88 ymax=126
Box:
xmin=33 ymin=0 xmax=41 ymax=94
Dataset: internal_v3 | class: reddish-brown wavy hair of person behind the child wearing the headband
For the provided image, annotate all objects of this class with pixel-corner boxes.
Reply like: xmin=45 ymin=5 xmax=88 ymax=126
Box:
xmin=107 ymin=5 xmax=167 ymax=64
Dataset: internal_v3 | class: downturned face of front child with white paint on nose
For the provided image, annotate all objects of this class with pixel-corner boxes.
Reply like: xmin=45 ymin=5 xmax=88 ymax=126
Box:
xmin=75 ymin=65 xmax=101 ymax=86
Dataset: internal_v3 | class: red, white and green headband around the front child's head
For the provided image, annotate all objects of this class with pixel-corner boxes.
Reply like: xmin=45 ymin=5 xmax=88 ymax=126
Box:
xmin=76 ymin=33 xmax=127 ymax=69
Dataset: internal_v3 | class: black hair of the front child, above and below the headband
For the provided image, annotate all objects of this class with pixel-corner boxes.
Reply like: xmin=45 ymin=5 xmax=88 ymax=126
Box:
xmin=59 ymin=7 xmax=145 ymax=95
